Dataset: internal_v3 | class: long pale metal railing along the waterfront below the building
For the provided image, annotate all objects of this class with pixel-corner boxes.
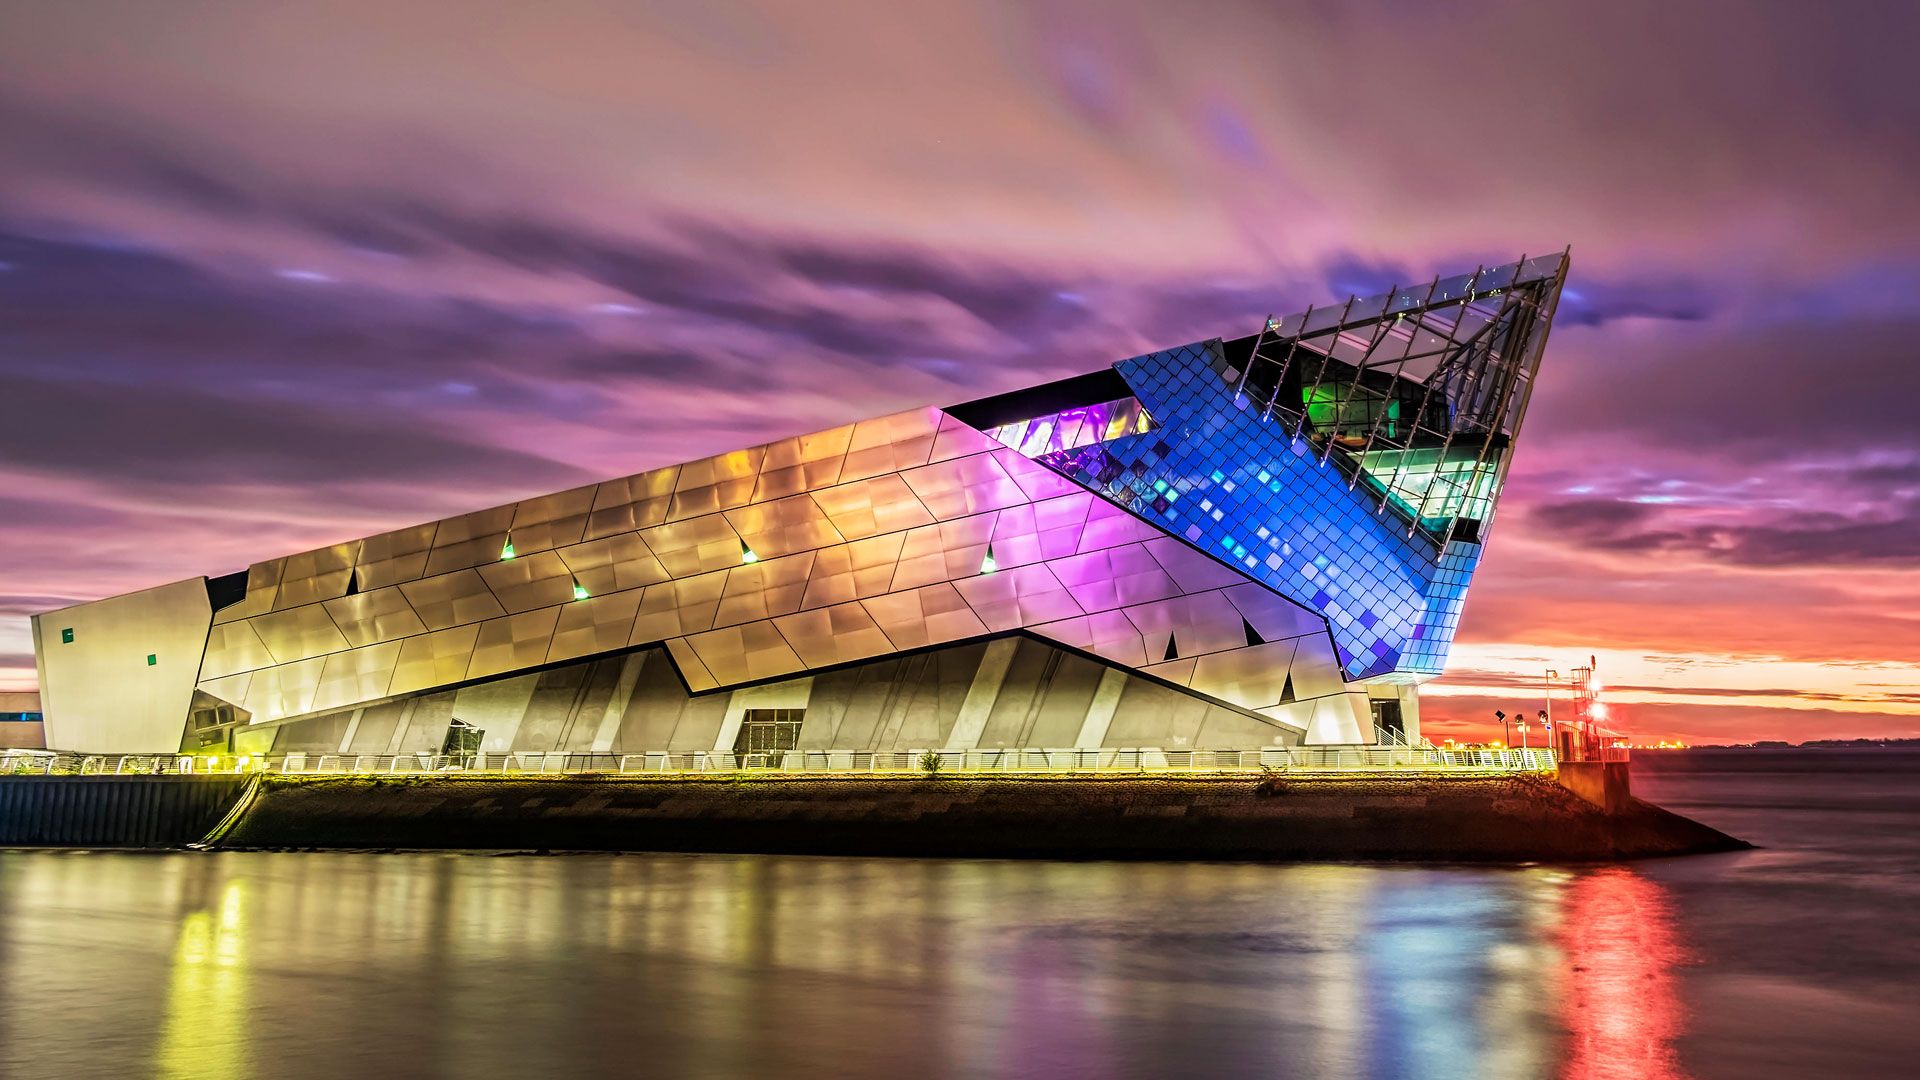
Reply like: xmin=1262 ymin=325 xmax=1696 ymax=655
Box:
xmin=0 ymin=746 xmax=1555 ymax=776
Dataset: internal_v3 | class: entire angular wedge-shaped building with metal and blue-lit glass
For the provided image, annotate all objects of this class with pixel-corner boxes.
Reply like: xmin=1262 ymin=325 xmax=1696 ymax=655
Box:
xmin=33 ymin=254 xmax=1567 ymax=753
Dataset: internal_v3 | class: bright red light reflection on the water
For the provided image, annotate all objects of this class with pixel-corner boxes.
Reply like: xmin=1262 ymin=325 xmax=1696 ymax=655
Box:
xmin=1559 ymin=867 xmax=1686 ymax=1080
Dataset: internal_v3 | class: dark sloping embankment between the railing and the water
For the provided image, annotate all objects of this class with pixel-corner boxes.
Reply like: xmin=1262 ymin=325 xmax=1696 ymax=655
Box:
xmin=221 ymin=776 xmax=1743 ymax=861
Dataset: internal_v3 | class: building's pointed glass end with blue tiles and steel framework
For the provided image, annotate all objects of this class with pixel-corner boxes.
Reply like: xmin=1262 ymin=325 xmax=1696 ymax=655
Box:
xmin=1041 ymin=256 xmax=1565 ymax=680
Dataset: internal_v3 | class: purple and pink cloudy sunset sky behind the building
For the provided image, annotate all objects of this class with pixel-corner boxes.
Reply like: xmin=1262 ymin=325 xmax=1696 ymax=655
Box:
xmin=0 ymin=0 xmax=1920 ymax=742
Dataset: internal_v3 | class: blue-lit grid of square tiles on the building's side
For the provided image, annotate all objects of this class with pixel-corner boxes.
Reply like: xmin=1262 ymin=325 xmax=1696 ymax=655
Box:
xmin=1041 ymin=340 xmax=1480 ymax=678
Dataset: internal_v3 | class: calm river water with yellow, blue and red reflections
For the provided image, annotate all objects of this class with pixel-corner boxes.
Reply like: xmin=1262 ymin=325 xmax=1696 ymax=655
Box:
xmin=0 ymin=751 xmax=1920 ymax=1080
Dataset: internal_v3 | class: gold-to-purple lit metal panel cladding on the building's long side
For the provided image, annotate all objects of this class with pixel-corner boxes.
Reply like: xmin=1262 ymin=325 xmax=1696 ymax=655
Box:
xmin=176 ymin=382 xmax=1367 ymax=719
